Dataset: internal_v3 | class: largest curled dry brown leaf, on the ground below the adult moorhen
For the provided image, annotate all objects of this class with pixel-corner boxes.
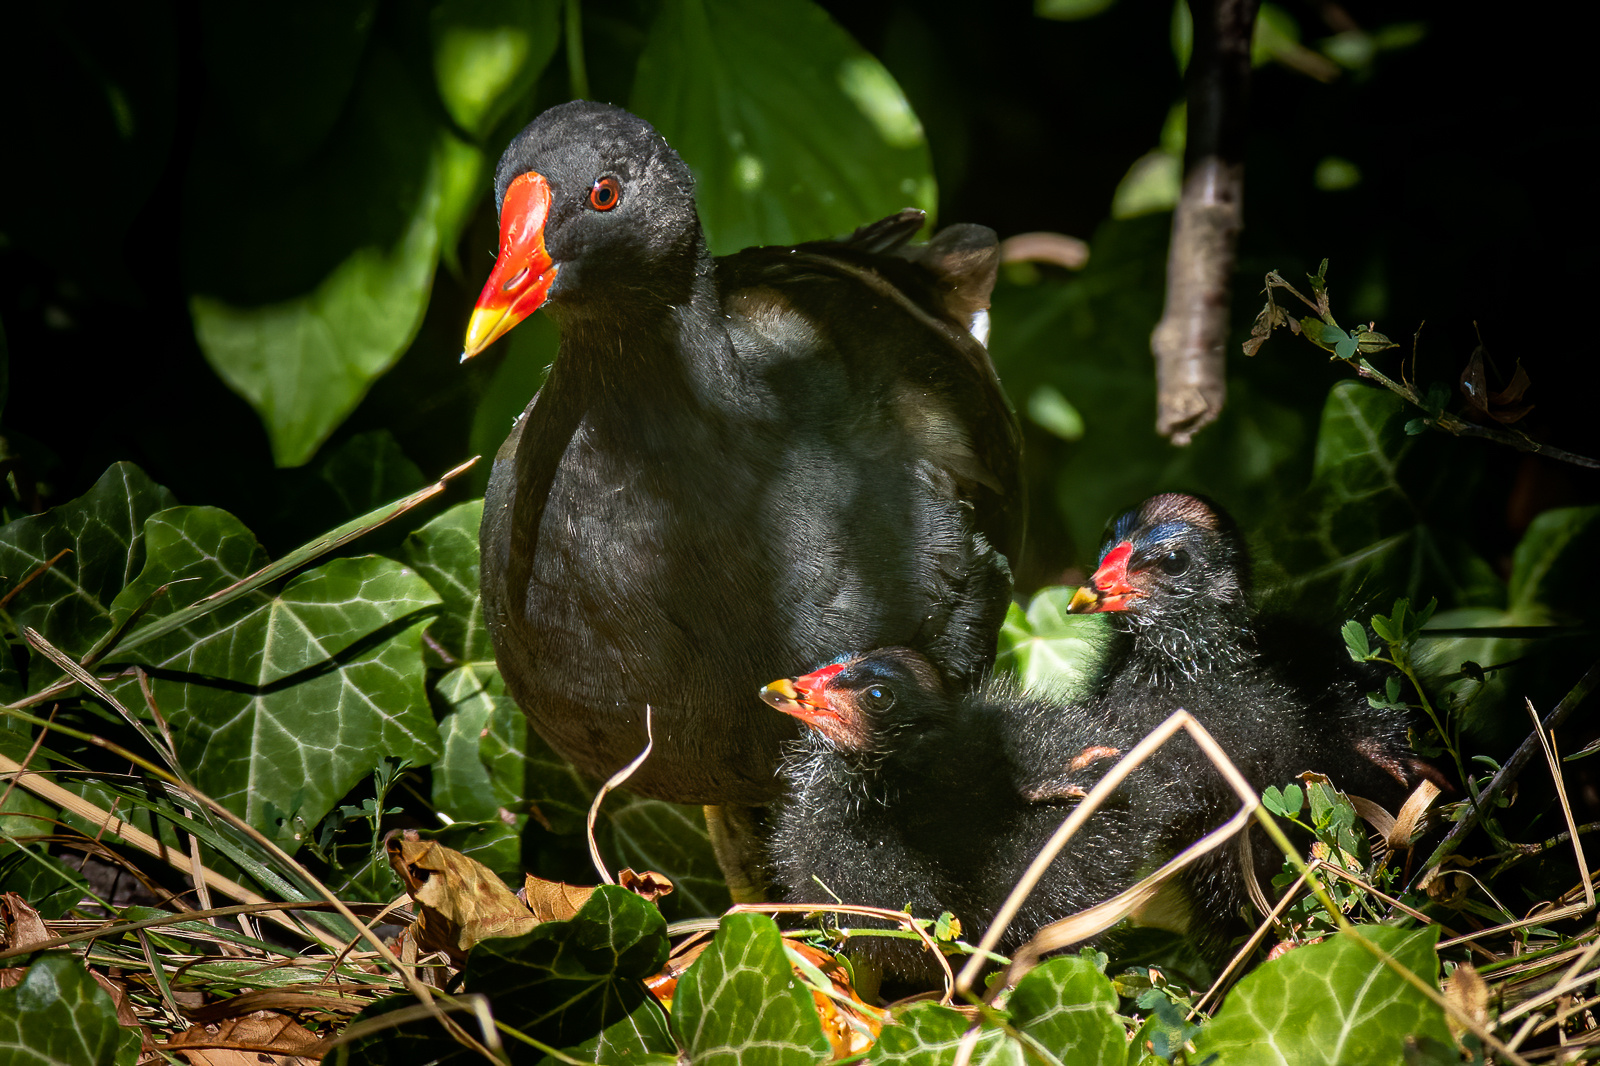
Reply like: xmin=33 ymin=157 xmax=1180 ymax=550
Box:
xmin=384 ymin=832 xmax=539 ymax=965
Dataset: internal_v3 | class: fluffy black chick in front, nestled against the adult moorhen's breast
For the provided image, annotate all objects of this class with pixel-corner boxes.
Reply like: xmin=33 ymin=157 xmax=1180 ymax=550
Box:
xmin=762 ymin=648 xmax=1162 ymax=984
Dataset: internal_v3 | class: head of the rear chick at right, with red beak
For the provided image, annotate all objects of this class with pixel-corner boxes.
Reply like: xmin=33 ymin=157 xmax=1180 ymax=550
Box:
xmin=1069 ymin=493 xmax=1254 ymax=677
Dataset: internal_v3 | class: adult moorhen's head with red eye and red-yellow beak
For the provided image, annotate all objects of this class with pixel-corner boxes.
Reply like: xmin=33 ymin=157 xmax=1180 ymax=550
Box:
xmin=466 ymin=101 xmax=707 ymax=355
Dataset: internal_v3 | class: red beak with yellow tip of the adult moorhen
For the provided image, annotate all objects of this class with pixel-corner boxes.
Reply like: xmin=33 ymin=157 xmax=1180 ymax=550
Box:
xmin=461 ymin=171 xmax=557 ymax=360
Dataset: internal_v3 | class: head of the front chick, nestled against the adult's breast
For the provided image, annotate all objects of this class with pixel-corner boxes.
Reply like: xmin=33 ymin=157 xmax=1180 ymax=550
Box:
xmin=762 ymin=648 xmax=958 ymax=770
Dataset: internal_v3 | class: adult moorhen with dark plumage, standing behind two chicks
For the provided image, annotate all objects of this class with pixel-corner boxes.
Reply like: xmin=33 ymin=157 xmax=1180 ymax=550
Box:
xmin=466 ymin=101 xmax=1021 ymax=804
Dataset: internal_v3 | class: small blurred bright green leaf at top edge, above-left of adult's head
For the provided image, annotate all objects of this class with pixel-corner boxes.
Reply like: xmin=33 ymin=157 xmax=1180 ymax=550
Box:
xmin=429 ymin=0 xmax=560 ymax=139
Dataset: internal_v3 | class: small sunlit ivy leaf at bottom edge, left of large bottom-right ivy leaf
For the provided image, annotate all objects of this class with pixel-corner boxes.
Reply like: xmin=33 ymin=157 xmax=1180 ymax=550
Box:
xmin=1011 ymin=956 xmax=1128 ymax=1066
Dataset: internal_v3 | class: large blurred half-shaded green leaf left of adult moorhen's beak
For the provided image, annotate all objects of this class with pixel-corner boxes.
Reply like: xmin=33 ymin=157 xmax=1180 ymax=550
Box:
xmin=186 ymin=42 xmax=486 ymax=466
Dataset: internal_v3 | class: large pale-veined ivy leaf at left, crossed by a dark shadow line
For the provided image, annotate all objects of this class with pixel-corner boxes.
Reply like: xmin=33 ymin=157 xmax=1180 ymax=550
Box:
xmin=107 ymin=544 xmax=438 ymax=834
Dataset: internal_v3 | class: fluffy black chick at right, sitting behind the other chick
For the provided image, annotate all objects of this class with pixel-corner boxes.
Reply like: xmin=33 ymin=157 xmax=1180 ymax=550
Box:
xmin=1062 ymin=493 xmax=1434 ymax=916
